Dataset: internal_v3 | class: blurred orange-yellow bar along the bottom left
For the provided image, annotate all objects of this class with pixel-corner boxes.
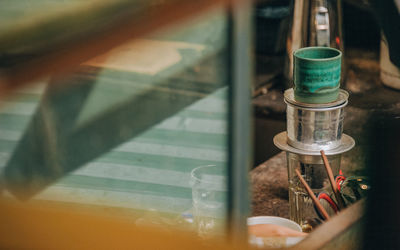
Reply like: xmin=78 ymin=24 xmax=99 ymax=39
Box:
xmin=0 ymin=200 xmax=249 ymax=250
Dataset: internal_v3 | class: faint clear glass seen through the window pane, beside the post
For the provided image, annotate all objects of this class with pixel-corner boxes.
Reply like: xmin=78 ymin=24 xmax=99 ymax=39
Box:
xmin=191 ymin=165 xmax=227 ymax=238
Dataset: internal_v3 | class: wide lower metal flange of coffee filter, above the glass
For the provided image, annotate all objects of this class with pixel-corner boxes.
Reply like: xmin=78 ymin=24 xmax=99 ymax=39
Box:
xmin=274 ymin=131 xmax=356 ymax=155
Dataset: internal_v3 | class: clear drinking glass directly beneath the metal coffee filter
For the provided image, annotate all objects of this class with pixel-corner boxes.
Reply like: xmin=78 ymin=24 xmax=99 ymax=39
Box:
xmin=286 ymin=152 xmax=341 ymax=231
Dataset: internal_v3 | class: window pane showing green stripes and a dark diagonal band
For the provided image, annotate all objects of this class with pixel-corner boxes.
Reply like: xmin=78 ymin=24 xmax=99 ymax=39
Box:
xmin=0 ymin=3 xmax=229 ymax=236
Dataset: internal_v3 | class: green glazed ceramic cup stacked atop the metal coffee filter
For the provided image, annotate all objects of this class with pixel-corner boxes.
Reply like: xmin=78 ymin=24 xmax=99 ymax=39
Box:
xmin=293 ymin=47 xmax=342 ymax=103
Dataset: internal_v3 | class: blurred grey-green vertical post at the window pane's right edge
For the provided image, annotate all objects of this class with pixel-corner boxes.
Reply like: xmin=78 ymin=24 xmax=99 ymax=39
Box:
xmin=228 ymin=0 xmax=252 ymax=241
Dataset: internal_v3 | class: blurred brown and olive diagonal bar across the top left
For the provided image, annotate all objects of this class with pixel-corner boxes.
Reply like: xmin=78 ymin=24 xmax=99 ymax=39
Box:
xmin=0 ymin=0 xmax=228 ymax=96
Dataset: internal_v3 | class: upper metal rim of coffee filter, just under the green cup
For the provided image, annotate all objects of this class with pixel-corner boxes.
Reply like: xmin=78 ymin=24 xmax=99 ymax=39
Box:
xmin=284 ymin=88 xmax=349 ymax=111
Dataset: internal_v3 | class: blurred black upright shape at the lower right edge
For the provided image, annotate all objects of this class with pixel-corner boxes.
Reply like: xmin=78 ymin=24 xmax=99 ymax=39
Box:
xmin=362 ymin=114 xmax=400 ymax=249
